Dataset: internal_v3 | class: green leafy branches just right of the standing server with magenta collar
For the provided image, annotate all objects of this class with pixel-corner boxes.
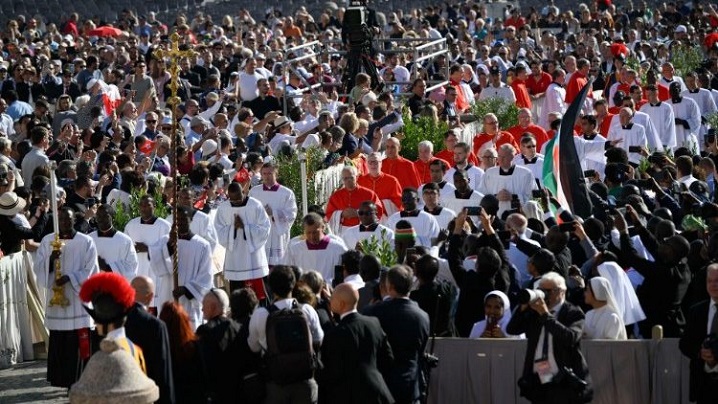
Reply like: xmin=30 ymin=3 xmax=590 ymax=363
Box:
xmin=276 ymin=147 xmax=324 ymax=237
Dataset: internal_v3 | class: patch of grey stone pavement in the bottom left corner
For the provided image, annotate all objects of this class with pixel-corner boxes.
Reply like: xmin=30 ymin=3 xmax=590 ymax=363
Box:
xmin=0 ymin=360 xmax=69 ymax=404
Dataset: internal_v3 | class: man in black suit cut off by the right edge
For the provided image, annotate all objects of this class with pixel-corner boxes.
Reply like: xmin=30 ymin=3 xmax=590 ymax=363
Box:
xmin=679 ymin=264 xmax=718 ymax=404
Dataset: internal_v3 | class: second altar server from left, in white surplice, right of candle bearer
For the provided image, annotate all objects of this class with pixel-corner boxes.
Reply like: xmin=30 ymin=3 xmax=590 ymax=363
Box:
xmin=90 ymin=204 xmax=138 ymax=282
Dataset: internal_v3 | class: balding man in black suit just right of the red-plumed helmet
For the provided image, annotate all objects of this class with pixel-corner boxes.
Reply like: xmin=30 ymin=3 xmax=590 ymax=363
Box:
xmin=125 ymin=276 xmax=175 ymax=404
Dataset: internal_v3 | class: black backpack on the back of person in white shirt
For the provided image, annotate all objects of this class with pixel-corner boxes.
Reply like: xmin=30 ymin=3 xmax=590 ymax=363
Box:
xmin=264 ymin=300 xmax=317 ymax=385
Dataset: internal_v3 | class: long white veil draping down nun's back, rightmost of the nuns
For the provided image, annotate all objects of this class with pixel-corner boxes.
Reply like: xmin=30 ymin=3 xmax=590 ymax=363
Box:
xmin=591 ymin=262 xmax=646 ymax=325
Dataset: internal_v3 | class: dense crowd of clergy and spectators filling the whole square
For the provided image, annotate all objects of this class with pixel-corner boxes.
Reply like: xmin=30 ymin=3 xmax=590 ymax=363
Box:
xmin=0 ymin=0 xmax=718 ymax=403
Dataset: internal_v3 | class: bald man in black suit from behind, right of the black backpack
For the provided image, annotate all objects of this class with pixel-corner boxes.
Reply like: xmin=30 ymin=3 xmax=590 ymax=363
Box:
xmin=317 ymin=283 xmax=394 ymax=404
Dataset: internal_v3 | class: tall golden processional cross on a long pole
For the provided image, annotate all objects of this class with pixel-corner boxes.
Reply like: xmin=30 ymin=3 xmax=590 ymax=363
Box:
xmin=154 ymin=32 xmax=196 ymax=299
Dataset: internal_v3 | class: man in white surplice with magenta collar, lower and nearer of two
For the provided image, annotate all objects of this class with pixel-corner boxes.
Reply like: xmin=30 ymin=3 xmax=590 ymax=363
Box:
xmin=287 ymin=213 xmax=348 ymax=284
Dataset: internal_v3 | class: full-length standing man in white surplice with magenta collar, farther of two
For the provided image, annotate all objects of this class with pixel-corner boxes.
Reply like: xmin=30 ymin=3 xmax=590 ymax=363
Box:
xmin=249 ymin=162 xmax=297 ymax=265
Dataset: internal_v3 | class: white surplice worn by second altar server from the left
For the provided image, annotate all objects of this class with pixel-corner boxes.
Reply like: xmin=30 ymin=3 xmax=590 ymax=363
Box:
xmin=90 ymin=231 xmax=138 ymax=282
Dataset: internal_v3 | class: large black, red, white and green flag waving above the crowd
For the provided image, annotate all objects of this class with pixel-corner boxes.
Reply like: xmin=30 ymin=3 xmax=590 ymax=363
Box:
xmin=543 ymin=81 xmax=593 ymax=218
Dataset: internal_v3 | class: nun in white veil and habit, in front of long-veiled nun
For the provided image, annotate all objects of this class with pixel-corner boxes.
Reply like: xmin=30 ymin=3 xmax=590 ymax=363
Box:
xmin=583 ymin=276 xmax=627 ymax=340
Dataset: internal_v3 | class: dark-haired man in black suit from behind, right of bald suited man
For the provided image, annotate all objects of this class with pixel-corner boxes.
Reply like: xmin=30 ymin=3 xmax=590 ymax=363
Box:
xmin=364 ymin=265 xmax=429 ymax=404
